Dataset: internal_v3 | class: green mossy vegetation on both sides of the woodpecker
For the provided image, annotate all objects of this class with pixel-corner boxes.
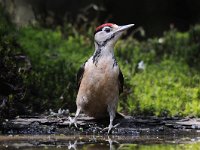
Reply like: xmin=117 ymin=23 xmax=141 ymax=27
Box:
xmin=0 ymin=6 xmax=200 ymax=117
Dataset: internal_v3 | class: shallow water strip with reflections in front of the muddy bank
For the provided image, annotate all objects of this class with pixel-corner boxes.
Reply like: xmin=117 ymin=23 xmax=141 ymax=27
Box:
xmin=0 ymin=135 xmax=200 ymax=150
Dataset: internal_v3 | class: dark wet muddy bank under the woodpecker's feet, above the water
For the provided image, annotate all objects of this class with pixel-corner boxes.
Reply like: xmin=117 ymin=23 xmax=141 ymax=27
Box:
xmin=0 ymin=115 xmax=200 ymax=136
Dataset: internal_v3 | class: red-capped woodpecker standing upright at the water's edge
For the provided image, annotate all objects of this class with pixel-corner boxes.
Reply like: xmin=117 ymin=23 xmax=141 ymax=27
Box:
xmin=69 ymin=23 xmax=134 ymax=133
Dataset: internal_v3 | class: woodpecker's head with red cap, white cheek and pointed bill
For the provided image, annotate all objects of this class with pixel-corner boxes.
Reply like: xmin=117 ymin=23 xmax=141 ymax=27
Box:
xmin=94 ymin=23 xmax=134 ymax=46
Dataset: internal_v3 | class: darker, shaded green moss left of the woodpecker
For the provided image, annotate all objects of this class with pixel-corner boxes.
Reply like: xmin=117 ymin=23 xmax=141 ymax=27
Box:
xmin=18 ymin=27 xmax=91 ymax=111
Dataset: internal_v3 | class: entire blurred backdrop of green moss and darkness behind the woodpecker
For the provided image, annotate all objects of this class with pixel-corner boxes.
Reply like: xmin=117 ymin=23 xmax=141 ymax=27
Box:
xmin=0 ymin=0 xmax=200 ymax=119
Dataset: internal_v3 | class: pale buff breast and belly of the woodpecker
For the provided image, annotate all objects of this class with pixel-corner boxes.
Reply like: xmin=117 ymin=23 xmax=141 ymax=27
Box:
xmin=77 ymin=58 xmax=119 ymax=118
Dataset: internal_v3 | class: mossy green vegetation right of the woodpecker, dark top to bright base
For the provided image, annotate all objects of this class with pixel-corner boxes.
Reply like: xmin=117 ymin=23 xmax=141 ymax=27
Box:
xmin=117 ymin=26 xmax=200 ymax=117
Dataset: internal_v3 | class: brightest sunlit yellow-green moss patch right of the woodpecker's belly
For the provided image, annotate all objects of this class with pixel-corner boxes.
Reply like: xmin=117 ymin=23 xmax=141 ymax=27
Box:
xmin=123 ymin=60 xmax=200 ymax=116
